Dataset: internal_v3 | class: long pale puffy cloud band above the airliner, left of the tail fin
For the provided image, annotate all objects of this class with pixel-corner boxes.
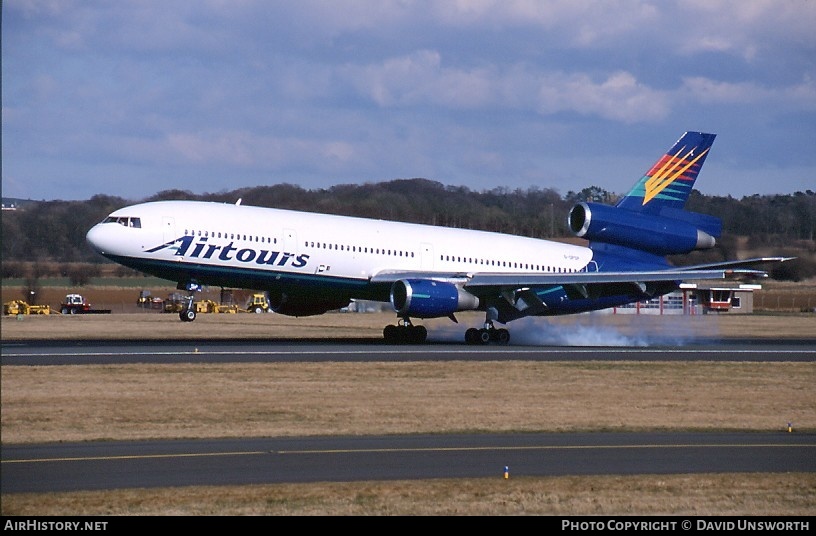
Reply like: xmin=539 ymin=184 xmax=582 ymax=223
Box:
xmin=339 ymin=51 xmax=670 ymax=123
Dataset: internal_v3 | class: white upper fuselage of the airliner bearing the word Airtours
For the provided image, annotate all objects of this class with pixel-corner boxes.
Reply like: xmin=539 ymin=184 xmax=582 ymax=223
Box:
xmin=88 ymin=201 xmax=592 ymax=280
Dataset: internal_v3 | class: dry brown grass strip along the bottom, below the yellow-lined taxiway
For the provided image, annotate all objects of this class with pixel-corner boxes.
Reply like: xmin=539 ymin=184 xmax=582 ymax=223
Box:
xmin=3 ymin=473 xmax=816 ymax=516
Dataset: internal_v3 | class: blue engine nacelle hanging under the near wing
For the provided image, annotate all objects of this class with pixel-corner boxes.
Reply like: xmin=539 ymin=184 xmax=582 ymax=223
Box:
xmin=391 ymin=279 xmax=479 ymax=318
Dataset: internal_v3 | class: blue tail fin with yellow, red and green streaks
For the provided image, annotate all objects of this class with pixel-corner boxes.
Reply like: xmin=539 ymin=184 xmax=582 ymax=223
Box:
xmin=616 ymin=132 xmax=716 ymax=214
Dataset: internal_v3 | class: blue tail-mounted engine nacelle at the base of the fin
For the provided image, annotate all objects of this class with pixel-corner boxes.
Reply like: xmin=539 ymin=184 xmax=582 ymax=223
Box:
xmin=567 ymin=203 xmax=716 ymax=255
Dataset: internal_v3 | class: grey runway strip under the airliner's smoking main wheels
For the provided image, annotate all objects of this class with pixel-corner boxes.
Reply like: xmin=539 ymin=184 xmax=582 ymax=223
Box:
xmin=0 ymin=339 xmax=816 ymax=366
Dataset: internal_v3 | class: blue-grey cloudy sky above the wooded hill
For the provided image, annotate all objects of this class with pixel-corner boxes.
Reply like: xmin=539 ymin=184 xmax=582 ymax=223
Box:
xmin=2 ymin=0 xmax=816 ymax=201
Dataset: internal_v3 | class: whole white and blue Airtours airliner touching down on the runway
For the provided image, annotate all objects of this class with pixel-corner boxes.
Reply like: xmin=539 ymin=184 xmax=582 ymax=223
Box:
xmin=87 ymin=132 xmax=787 ymax=344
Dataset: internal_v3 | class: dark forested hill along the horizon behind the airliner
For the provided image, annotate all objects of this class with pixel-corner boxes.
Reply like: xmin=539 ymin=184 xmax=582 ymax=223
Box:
xmin=2 ymin=179 xmax=816 ymax=278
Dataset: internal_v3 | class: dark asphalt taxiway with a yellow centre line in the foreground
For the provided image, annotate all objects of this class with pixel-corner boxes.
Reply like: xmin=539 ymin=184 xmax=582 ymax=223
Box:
xmin=1 ymin=432 xmax=816 ymax=494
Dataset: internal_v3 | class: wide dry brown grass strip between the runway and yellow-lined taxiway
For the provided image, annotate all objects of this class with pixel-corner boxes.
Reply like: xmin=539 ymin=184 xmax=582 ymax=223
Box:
xmin=2 ymin=361 xmax=816 ymax=444
